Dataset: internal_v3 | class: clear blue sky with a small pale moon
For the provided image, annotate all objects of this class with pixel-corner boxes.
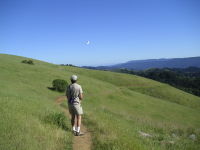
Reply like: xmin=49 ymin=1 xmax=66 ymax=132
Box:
xmin=0 ymin=0 xmax=200 ymax=66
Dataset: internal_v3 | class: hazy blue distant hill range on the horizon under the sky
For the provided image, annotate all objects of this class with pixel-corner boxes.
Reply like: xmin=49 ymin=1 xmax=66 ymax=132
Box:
xmin=83 ymin=57 xmax=200 ymax=70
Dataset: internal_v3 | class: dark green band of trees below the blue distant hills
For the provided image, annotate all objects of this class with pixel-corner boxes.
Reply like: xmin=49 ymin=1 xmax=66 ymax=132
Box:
xmin=113 ymin=67 xmax=200 ymax=96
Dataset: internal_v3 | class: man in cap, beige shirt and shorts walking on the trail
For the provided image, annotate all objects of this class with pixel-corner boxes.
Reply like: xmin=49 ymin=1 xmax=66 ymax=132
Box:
xmin=66 ymin=75 xmax=83 ymax=136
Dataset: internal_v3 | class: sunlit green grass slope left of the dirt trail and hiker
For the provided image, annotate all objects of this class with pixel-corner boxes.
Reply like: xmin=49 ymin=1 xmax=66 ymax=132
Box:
xmin=0 ymin=54 xmax=72 ymax=150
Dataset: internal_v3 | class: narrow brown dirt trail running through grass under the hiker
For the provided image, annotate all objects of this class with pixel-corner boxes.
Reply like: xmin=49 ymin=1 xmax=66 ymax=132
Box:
xmin=56 ymin=96 xmax=92 ymax=150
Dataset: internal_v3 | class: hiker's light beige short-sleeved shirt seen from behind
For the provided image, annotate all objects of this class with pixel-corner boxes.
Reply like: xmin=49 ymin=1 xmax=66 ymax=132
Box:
xmin=66 ymin=83 xmax=83 ymax=103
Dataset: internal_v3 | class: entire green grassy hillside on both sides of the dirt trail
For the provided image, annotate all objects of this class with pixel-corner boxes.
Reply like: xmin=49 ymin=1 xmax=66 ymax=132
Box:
xmin=0 ymin=54 xmax=200 ymax=150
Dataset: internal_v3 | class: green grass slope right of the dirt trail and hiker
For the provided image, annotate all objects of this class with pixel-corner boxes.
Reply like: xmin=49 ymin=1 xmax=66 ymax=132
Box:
xmin=60 ymin=67 xmax=200 ymax=150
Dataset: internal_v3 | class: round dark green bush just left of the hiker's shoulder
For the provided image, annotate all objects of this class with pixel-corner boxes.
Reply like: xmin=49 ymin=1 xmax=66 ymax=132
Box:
xmin=52 ymin=79 xmax=68 ymax=92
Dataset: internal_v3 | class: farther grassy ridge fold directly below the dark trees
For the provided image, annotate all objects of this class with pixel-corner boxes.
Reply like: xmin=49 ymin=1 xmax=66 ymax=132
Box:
xmin=67 ymin=67 xmax=200 ymax=110
